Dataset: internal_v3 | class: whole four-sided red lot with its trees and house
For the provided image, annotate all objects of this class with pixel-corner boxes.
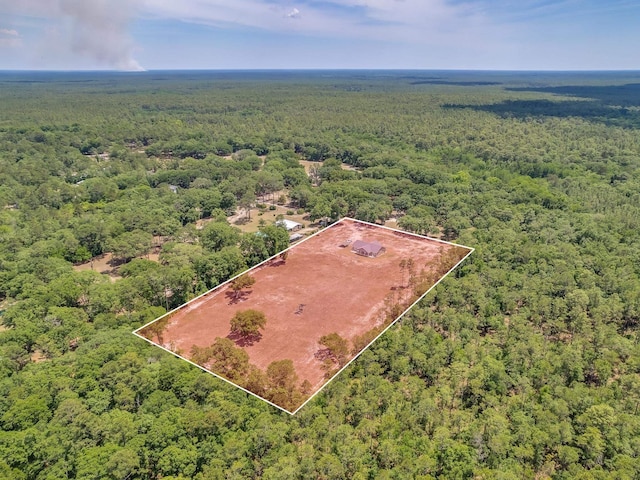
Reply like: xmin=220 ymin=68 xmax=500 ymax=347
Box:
xmin=135 ymin=218 xmax=472 ymax=413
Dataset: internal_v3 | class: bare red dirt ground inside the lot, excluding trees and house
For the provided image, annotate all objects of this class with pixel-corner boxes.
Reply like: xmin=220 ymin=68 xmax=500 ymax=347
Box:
xmin=139 ymin=219 xmax=470 ymax=408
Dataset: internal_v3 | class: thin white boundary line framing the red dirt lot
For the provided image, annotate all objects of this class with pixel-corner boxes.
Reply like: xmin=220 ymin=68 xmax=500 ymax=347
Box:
xmin=132 ymin=217 xmax=475 ymax=415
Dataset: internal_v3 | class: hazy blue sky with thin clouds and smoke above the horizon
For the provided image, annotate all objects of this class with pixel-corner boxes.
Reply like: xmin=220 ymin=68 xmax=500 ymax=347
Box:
xmin=0 ymin=0 xmax=640 ymax=71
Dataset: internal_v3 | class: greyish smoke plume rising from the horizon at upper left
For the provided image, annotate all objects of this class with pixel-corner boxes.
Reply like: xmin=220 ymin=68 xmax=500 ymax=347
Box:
xmin=59 ymin=0 xmax=144 ymax=71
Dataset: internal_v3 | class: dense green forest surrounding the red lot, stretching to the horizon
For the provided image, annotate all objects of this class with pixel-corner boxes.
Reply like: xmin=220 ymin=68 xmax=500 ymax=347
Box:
xmin=0 ymin=72 xmax=640 ymax=480
